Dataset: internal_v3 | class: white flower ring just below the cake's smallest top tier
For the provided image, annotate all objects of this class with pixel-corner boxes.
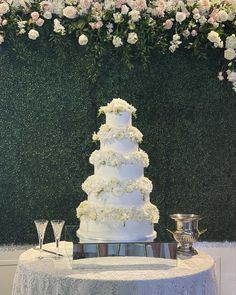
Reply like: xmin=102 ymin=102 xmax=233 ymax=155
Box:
xmin=93 ymin=124 xmax=143 ymax=143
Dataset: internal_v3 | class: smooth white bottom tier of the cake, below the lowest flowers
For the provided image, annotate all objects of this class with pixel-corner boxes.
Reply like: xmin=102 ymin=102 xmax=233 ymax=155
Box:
xmin=77 ymin=218 xmax=156 ymax=243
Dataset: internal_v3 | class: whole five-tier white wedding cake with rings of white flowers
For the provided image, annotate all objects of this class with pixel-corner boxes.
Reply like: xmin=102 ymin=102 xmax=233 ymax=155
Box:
xmin=77 ymin=98 xmax=159 ymax=242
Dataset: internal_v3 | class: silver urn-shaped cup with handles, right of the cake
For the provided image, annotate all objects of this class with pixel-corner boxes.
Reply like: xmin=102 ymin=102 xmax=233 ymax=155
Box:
xmin=167 ymin=214 xmax=207 ymax=256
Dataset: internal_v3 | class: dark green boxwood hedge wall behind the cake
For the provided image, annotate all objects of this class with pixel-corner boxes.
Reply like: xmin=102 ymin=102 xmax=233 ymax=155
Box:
xmin=0 ymin=48 xmax=236 ymax=244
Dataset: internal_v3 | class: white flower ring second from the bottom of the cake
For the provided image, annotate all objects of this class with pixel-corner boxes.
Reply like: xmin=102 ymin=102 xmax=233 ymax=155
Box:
xmin=82 ymin=175 xmax=153 ymax=199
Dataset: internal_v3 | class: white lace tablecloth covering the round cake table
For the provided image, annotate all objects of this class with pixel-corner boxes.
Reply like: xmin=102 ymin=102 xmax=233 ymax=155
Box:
xmin=12 ymin=242 xmax=217 ymax=295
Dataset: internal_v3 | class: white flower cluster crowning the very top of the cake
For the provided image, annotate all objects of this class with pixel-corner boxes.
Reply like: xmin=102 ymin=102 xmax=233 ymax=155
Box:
xmin=99 ymin=98 xmax=136 ymax=115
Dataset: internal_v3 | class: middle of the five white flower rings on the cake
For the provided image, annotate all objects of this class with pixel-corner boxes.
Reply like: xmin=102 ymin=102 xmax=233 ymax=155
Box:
xmin=89 ymin=149 xmax=149 ymax=167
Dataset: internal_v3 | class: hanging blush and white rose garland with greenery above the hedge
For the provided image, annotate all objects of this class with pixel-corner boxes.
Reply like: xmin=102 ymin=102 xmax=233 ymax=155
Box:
xmin=0 ymin=0 xmax=236 ymax=91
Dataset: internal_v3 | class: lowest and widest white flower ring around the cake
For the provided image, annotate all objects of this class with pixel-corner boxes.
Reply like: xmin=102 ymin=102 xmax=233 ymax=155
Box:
xmin=77 ymin=201 xmax=159 ymax=224
